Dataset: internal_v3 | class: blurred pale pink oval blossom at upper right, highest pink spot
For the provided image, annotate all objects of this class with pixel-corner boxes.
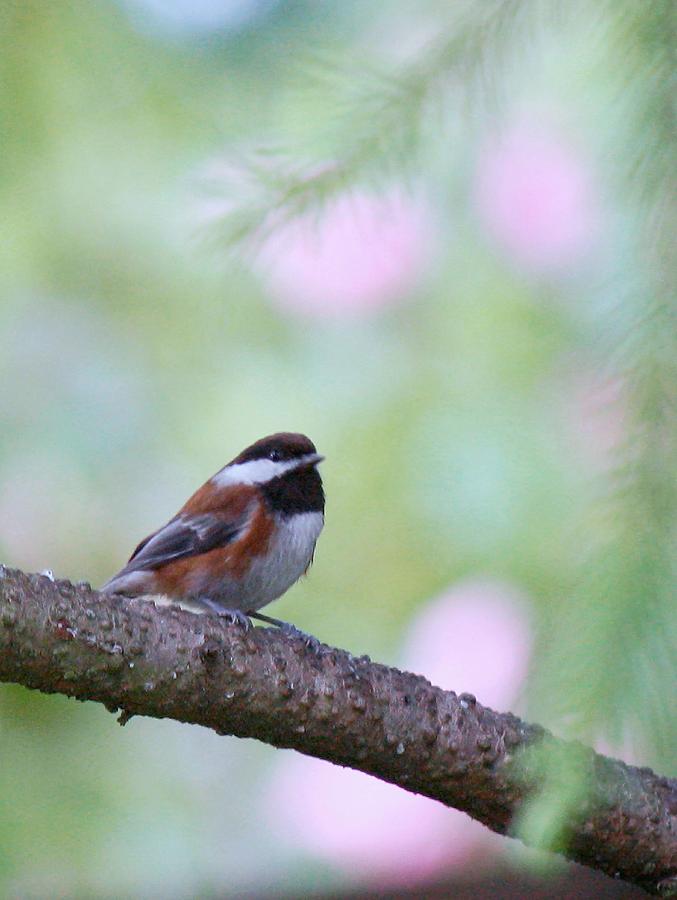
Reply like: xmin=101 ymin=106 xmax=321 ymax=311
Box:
xmin=475 ymin=125 xmax=597 ymax=271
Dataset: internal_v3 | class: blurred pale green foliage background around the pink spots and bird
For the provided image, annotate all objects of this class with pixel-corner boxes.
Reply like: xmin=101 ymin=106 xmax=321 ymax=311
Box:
xmin=0 ymin=0 xmax=677 ymax=897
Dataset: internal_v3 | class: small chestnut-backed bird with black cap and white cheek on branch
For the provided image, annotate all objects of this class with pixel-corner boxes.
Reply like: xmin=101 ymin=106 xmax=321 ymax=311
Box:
xmin=101 ymin=432 xmax=324 ymax=631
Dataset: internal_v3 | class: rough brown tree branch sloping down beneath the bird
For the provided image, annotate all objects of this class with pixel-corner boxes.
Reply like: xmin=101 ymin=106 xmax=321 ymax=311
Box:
xmin=0 ymin=566 xmax=677 ymax=896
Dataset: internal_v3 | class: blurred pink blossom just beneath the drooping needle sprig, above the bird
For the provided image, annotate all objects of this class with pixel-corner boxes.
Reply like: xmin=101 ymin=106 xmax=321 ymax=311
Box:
xmin=260 ymin=190 xmax=433 ymax=319
